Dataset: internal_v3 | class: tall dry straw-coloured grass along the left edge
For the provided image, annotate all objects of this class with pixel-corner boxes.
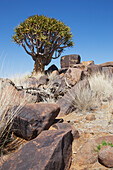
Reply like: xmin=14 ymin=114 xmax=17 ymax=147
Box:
xmin=0 ymin=83 xmax=26 ymax=155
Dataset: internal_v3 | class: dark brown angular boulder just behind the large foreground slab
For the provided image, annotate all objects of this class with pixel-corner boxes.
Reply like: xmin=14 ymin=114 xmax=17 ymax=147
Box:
xmin=12 ymin=103 xmax=60 ymax=140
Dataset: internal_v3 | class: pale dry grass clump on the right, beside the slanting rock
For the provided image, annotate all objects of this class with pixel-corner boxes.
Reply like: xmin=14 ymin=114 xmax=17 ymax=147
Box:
xmin=70 ymin=73 xmax=113 ymax=113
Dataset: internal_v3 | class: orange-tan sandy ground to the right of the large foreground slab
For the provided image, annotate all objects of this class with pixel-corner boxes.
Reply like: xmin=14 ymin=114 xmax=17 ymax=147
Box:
xmin=60 ymin=109 xmax=113 ymax=170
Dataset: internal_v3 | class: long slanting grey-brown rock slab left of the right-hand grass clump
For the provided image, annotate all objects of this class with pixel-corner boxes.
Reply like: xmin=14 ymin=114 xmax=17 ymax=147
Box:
xmin=57 ymin=79 xmax=90 ymax=116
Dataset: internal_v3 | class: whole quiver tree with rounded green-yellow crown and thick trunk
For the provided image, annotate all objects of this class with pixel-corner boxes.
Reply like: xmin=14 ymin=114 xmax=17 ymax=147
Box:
xmin=13 ymin=15 xmax=73 ymax=75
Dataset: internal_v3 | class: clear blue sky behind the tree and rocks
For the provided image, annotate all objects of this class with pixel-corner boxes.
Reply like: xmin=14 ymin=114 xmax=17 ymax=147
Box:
xmin=0 ymin=0 xmax=113 ymax=77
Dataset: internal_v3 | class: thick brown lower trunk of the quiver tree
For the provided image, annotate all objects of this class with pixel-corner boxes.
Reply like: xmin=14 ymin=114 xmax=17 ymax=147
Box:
xmin=32 ymin=58 xmax=45 ymax=76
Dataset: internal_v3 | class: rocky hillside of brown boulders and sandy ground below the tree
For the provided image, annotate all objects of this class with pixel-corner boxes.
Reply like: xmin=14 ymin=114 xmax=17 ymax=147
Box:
xmin=0 ymin=55 xmax=113 ymax=170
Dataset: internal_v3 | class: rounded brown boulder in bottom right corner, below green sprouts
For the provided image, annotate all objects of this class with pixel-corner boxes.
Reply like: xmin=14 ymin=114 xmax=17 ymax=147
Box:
xmin=98 ymin=146 xmax=113 ymax=168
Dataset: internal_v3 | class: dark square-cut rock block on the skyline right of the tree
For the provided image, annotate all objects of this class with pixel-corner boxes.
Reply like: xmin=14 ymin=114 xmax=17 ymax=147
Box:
xmin=60 ymin=54 xmax=81 ymax=68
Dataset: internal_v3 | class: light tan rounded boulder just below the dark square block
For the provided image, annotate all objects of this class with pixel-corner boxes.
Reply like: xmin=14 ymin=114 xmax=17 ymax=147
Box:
xmin=65 ymin=68 xmax=84 ymax=86
